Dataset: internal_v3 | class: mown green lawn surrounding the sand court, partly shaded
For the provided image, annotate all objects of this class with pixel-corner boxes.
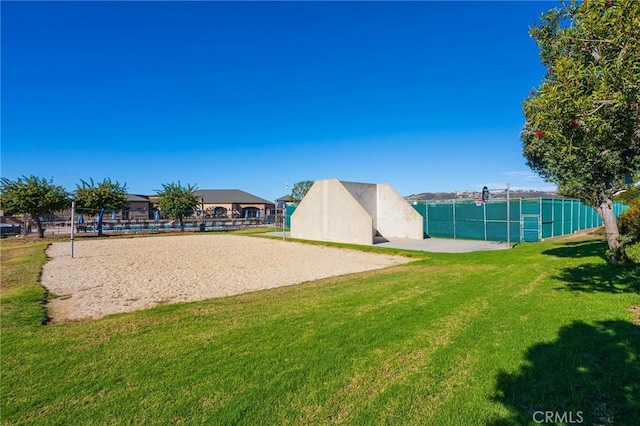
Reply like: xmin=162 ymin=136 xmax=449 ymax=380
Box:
xmin=0 ymin=236 xmax=640 ymax=425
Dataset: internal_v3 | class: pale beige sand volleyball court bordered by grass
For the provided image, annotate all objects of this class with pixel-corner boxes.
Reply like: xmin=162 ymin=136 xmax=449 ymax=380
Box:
xmin=42 ymin=234 xmax=411 ymax=323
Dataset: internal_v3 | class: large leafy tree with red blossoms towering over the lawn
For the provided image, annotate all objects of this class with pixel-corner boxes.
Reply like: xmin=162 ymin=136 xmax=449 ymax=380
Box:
xmin=521 ymin=0 xmax=640 ymax=260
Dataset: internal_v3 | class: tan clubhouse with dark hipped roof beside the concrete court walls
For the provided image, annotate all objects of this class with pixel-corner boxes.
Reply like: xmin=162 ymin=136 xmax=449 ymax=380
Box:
xmin=194 ymin=189 xmax=275 ymax=218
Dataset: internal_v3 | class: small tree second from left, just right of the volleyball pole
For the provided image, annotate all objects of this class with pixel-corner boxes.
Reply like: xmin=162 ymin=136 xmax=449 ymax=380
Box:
xmin=75 ymin=178 xmax=129 ymax=236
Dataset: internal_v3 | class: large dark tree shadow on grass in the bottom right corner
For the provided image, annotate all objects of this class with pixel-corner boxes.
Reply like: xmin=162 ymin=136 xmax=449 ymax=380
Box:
xmin=490 ymin=321 xmax=640 ymax=426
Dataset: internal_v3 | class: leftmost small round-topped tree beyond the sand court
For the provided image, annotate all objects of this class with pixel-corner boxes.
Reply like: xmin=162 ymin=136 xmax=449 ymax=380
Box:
xmin=0 ymin=175 xmax=71 ymax=238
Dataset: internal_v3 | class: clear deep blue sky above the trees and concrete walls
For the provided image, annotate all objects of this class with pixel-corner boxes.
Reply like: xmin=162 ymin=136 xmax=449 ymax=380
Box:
xmin=1 ymin=1 xmax=559 ymax=199
